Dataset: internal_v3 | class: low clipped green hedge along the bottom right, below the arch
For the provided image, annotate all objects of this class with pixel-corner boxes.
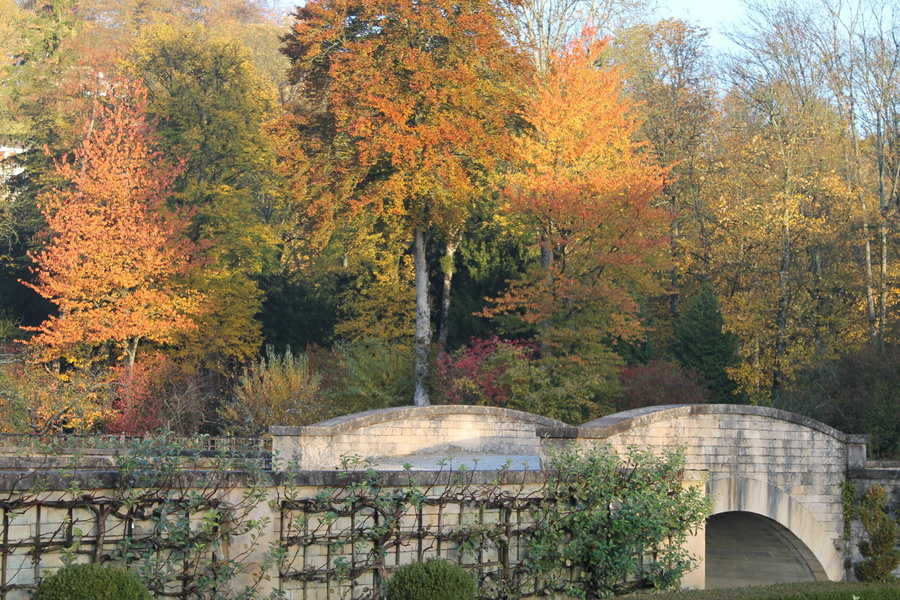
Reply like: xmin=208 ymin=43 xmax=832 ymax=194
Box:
xmin=653 ymin=582 xmax=900 ymax=600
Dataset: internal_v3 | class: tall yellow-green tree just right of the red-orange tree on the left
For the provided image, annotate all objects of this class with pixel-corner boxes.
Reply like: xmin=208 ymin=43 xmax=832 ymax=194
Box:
xmin=131 ymin=25 xmax=282 ymax=370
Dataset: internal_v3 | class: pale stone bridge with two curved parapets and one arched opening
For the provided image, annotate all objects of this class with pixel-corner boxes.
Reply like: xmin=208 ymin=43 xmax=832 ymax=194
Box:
xmin=270 ymin=405 xmax=871 ymax=588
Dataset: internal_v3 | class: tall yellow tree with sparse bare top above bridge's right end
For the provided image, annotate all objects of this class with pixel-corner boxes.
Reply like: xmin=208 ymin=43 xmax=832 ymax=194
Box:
xmin=709 ymin=4 xmax=863 ymax=403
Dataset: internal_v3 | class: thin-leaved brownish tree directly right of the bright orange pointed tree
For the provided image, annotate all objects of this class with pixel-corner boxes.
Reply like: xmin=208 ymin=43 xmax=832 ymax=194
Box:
xmin=607 ymin=19 xmax=717 ymax=318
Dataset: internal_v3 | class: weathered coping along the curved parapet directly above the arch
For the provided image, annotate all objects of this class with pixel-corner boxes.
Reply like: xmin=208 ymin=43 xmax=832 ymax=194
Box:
xmin=537 ymin=404 xmax=869 ymax=444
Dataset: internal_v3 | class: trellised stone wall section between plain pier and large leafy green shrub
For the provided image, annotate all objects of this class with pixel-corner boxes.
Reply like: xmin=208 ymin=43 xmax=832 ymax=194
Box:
xmin=279 ymin=471 xmax=543 ymax=600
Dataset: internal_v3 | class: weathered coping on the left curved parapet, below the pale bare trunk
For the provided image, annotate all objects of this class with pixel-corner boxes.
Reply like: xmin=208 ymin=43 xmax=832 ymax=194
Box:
xmin=269 ymin=404 xmax=574 ymax=436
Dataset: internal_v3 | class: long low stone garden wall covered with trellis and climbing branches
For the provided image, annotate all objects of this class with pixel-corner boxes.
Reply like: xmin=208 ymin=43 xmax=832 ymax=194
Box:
xmin=0 ymin=456 xmax=544 ymax=600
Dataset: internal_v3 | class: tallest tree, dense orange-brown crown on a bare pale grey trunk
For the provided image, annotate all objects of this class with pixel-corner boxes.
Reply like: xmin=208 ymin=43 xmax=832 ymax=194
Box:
xmin=284 ymin=0 xmax=524 ymax=405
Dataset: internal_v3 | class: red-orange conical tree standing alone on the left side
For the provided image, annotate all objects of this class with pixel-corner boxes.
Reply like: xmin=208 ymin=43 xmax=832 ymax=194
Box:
xmin=26 ymin=79 xmax=198 ymax=367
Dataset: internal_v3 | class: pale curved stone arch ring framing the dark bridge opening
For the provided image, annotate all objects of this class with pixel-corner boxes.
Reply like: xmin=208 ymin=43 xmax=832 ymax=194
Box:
xmin=706 ymin=477 xmax=843 ymax=581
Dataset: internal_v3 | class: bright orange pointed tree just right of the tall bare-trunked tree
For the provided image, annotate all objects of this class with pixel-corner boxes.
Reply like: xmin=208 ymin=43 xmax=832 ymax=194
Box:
xmin=485 ymin=35 xmax=666 ymax=408
